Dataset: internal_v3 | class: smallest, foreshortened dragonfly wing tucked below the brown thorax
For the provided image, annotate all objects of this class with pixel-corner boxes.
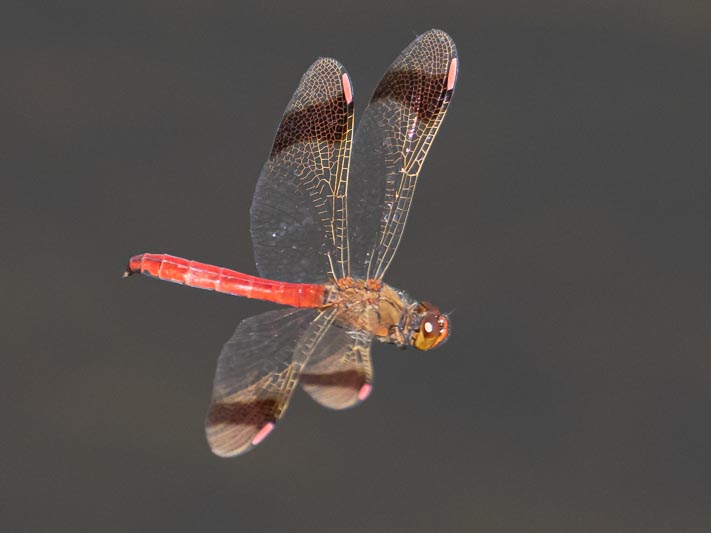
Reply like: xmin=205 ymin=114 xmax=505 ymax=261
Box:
xmin=301 ymin=325 xmax=373 ymax=409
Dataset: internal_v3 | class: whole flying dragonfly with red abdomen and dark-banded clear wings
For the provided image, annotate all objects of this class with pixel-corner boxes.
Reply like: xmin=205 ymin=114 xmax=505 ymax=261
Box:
xmin=125 ymin=30 xmax=459 ymax=457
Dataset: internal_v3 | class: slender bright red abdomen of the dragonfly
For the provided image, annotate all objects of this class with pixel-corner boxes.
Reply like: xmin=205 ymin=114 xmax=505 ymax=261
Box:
xmin=126 ymin=254 xmax=326 ymax=307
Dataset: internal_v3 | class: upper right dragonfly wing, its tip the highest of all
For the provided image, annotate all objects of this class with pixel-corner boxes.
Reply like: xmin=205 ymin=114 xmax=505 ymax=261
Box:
xmin=348 ymin=30 xmax=458 ymax=279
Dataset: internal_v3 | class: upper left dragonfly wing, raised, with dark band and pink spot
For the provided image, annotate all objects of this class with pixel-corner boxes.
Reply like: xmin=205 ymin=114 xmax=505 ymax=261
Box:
xmin=251 ymin=58 xmax=353 ymax=283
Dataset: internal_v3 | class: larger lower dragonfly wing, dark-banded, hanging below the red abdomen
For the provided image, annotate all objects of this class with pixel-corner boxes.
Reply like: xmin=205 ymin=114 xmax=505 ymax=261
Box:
xmin=205 ymin=309 xmax=335 ymax=457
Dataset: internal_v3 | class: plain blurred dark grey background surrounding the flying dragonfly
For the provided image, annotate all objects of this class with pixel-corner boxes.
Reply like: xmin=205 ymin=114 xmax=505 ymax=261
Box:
xmin=0 ymin=0 xmax=711 ymax=532
